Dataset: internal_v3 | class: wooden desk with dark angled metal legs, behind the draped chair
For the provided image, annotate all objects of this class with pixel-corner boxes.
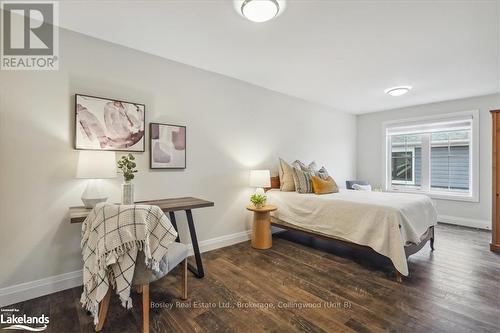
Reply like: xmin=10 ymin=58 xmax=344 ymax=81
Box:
xmin=69 ymin=197 xmax=214 ymax=278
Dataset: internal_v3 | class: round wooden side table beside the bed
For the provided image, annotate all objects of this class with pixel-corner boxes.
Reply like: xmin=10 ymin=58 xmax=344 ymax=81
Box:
xmin=247 ymin=205 xmax=278 ymax=250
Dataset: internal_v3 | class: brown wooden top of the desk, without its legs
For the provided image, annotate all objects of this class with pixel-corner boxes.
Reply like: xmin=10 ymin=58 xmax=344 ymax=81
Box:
xmin=69 ymin=197 xmax=214 ymax=223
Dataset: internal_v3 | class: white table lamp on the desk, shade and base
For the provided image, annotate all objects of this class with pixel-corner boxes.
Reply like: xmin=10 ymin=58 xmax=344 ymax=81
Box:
xmin=76 ymin=150 xmax=116 ymax=208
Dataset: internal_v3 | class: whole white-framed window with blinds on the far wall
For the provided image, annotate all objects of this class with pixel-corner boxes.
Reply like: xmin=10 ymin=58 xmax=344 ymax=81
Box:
xmin=384 ymin=111 xmax=479 ymax=201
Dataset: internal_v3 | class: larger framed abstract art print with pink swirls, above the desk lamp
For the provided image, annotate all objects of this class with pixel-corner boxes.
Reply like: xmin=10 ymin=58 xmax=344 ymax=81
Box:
xmin=75 ymin=94 xmax=146 ymax=152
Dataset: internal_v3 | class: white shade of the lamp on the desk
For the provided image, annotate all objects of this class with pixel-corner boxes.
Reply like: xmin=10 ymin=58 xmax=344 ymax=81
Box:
xmin=76 ymin=150 xmax=116 ymax=179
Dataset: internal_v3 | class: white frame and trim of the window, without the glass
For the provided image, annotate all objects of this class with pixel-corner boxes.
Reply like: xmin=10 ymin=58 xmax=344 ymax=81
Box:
xmin=382 ymin=110 xmax=479 ymax=202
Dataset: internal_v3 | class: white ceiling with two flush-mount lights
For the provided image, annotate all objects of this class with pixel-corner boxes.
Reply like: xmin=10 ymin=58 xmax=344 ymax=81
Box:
xmin=56 ymin=0 xmax=500 ymax=113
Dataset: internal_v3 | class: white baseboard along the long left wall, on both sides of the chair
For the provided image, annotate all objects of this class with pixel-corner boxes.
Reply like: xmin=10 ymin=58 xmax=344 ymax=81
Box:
xmin=0 ymin=230 xmax=252 ymax=307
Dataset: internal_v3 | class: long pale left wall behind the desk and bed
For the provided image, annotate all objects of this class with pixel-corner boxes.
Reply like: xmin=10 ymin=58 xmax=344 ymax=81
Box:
xmin=0 ymin=30 xmax=356 ymax=303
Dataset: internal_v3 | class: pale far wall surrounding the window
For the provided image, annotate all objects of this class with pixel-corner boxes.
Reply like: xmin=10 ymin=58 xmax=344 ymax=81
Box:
xmin=357 ymin=95 xmax=500 ymax=228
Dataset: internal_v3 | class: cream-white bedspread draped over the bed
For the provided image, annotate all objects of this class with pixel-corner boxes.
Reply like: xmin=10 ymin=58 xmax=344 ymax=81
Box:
xmin=266 ymin=190 xmax=437 ymax=276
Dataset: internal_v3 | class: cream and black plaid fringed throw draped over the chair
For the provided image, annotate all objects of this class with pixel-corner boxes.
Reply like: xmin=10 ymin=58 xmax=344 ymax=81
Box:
xmin=81 ymin=203 xmax=177 ymax=324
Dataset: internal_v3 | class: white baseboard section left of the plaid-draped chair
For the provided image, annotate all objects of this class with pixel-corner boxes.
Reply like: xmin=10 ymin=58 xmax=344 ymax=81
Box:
xmin=0 ymin=270 xmax=83 ymax=307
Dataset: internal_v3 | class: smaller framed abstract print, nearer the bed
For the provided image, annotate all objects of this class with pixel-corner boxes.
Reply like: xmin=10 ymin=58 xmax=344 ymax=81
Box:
xmin=149 ymin=123 xmax=186 ymax=169
